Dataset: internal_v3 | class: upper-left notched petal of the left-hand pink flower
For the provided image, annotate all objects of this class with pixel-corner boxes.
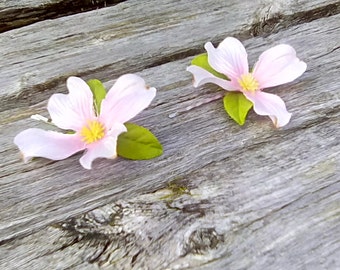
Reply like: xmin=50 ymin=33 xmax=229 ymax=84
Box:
xmin=47 ymin=77 xmax=95 ymax=131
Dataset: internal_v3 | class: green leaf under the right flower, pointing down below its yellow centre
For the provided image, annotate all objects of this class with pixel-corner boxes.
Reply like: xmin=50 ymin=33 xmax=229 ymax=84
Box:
xmin=223 ymin=92 xmax=253 ymax=126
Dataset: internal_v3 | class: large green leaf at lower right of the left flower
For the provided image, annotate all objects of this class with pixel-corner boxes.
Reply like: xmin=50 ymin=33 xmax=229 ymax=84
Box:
xmin=117 ymin=123 xmax=163 ymax=160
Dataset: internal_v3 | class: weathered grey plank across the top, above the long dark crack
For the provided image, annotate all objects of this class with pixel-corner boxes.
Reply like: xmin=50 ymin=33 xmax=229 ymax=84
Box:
xmin=0 ymin=0 xmax=340 ymax=110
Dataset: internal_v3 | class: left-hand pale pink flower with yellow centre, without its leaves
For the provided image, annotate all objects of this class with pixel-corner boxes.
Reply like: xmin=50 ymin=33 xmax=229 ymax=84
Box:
xmin=14 ymin=74 xmax=156 ymax=169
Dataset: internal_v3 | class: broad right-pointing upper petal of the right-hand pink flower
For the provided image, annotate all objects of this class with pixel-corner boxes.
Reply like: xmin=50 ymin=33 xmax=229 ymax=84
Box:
xmin=253 ymin=44 xmax=307 ymax=89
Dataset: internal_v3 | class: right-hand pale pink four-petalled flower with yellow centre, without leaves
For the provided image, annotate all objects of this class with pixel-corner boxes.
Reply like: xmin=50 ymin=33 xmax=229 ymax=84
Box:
xmin=187 ymin=37 xmax=307 ymax=127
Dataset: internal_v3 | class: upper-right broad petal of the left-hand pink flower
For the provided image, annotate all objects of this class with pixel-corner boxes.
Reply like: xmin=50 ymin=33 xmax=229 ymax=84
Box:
xmin=100 ymin=74 xmax=156 ymax=126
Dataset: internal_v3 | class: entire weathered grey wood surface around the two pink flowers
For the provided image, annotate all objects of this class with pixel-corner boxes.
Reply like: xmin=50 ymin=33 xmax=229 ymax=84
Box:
xmin=0 ymin=1 xmax=340 ymax=269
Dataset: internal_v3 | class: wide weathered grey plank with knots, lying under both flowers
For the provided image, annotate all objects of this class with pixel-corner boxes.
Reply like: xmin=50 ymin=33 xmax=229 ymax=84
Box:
xmin=1 ymin=9 xmax=340 ymax=269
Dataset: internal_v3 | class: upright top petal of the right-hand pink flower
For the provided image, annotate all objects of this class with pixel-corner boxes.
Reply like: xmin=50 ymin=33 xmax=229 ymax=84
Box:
xmin=204 ymin=37 xmax=249 ymax=80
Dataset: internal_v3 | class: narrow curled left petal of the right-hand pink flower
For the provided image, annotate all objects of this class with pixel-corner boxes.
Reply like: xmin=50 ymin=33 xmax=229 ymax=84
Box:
xmin=187 ymin=65 xmax=236 ymax=90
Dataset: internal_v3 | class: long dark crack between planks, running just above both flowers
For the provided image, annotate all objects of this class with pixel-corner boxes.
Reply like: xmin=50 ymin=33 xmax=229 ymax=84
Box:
xmin=0 ymin=3 xmax=340 ymax=111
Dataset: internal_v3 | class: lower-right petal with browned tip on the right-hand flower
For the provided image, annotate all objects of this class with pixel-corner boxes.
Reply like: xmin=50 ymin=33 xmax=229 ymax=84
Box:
xmin=243 ymin=91 xmax=292 ymax=127
